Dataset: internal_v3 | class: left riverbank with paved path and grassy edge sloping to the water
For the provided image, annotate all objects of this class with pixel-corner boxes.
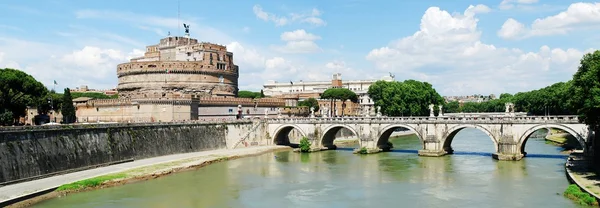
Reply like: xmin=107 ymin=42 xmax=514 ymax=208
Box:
xmin=0 ymin=146 xmax=290 ymax=207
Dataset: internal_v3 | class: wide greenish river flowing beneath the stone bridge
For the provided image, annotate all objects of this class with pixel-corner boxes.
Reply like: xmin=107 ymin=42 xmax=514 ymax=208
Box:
xmin=35 ymin=129 xmax=582 ymax=208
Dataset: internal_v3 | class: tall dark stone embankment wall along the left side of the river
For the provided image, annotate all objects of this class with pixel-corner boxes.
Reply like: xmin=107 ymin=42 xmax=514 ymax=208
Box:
xmin=0 ymin=121 xmax=268 ymax=183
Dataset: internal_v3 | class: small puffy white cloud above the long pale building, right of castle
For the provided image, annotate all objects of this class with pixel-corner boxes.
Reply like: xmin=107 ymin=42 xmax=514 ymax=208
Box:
xmin=272 ymin=30 xmax=321 ymax=53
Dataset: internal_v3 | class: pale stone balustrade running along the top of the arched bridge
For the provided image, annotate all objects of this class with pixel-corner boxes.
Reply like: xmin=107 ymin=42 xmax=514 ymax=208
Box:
xmin=268 ymin=115 xmax=580 ymax=124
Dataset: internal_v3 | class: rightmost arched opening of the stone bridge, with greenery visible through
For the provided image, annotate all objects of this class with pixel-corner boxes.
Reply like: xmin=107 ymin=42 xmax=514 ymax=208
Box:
xmin=520 ymin=124 xmax=585 ymax=156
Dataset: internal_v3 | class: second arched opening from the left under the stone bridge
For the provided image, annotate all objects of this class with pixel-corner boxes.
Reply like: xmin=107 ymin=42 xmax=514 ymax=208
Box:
xmin=321 ymin=126 xmax=360 ymax=150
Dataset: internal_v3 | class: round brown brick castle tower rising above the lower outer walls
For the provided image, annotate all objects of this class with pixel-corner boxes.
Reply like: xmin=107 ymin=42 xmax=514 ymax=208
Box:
xmin=117 ymin=37 xmax=239 ymax=98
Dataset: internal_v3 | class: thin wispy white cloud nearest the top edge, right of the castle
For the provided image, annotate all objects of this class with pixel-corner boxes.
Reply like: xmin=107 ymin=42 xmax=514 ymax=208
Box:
xmin=252 ymin=5 xmax=327 ymax=26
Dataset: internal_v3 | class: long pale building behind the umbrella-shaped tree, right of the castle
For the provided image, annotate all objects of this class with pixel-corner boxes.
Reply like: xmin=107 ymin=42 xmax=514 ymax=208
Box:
xmin=263 ymin=73 xmax=394 ymax=115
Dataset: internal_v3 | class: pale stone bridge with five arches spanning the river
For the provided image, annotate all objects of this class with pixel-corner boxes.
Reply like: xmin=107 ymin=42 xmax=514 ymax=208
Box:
xmin=266 ymin=116 xmax=591 ymax=160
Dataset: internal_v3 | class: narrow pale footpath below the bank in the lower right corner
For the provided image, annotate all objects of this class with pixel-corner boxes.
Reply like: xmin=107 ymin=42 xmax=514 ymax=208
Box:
xmin=566 ymin=153 xmax=600 ymax=199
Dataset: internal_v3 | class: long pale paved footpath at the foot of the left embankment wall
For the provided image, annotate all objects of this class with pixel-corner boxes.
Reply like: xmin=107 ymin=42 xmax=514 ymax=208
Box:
xmin=0 ymin=146 xmax=289 ymax=206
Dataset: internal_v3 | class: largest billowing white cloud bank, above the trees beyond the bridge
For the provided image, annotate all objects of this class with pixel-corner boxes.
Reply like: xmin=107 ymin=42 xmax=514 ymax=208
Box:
xmin=366 ymin=4 xmax=590 ymax=95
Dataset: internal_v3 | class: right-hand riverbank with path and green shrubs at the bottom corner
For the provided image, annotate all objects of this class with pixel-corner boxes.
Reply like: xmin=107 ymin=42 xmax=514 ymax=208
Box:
xmin=565 ymin=153 xmax=600 ymax=206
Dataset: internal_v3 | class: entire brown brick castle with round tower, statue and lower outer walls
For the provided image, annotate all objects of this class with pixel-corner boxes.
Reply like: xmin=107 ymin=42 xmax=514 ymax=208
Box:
xmin=74 ymin=32 xmax=285 ymax=123
